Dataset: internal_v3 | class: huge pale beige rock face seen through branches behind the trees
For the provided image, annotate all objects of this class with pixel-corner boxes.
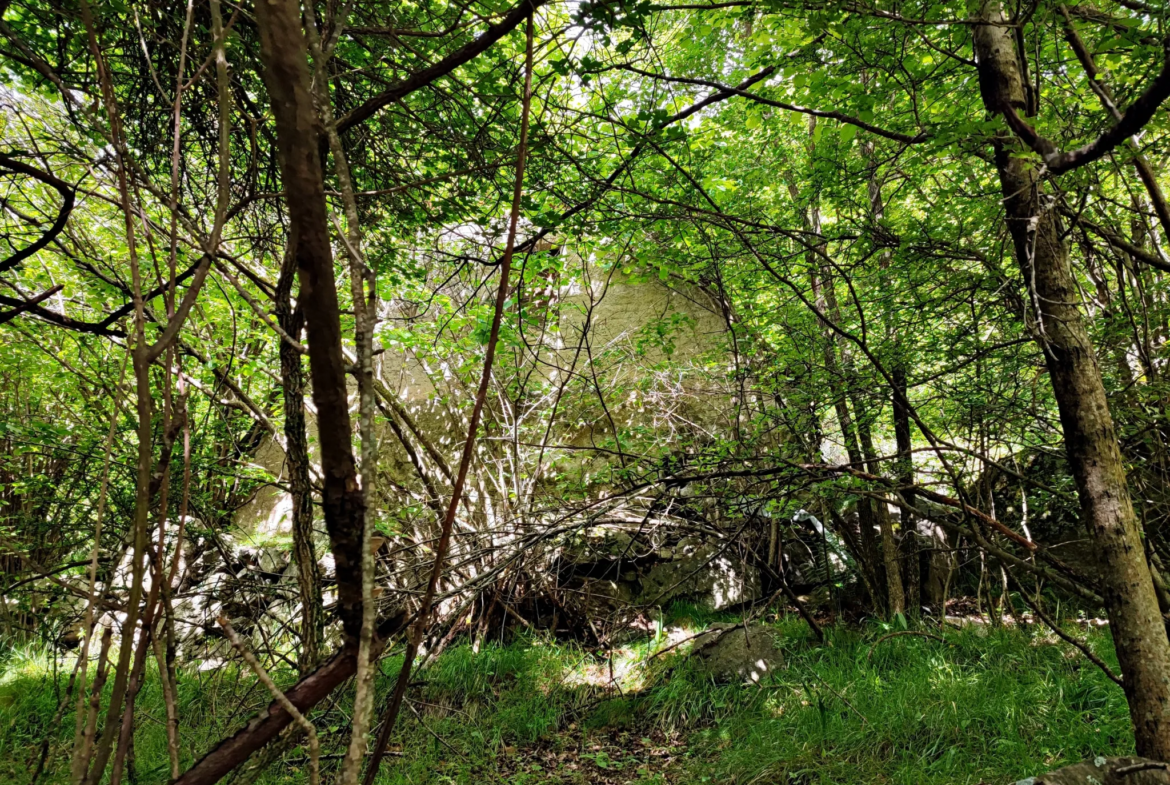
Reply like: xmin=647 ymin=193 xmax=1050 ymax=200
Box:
xmin=235 ymin=253 xmax=727 ymax=538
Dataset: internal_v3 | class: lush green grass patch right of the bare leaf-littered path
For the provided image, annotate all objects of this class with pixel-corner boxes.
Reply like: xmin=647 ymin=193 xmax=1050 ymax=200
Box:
xmin=678 ymin=631 xmax=1133 ymax=784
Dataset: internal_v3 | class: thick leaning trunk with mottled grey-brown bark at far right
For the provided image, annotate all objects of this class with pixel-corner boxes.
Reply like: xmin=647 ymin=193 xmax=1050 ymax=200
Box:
xmin=975 ymin=0 xmax=1170 ymax=760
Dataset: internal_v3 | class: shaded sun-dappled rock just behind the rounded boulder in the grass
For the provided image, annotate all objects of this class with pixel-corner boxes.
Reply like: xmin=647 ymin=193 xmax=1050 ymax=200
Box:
xmin=639 ymin=543 xmax=763 ymax=611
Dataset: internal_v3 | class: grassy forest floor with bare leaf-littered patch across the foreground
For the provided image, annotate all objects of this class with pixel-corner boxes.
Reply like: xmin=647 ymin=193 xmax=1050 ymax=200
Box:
xmin=0 ymin=608 xmax=1133 ymax=785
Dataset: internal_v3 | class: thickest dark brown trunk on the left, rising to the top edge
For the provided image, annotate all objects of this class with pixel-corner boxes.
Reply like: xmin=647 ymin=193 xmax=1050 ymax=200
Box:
xmin=256 ymin=0 xmax=365 ymax=642
